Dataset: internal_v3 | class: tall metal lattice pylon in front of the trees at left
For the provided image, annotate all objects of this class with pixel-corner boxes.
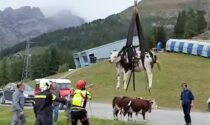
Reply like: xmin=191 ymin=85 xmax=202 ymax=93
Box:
xmin=21 ymin=40 xmax=32 ymax=80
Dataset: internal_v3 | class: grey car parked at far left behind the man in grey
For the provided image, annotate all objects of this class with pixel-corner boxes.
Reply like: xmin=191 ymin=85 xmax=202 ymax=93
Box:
xmin=0 ymin=83 xmax=34 ymax=104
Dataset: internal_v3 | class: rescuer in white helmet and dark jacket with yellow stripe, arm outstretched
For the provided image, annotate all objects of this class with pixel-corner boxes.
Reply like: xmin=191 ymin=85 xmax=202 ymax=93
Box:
xmin=34 ymin=82 xmax=67 ymax=125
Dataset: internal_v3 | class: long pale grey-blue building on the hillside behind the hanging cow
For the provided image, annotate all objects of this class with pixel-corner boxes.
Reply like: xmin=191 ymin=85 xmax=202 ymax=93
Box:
xmin=73 ymin=37 xmax=139 ymax=68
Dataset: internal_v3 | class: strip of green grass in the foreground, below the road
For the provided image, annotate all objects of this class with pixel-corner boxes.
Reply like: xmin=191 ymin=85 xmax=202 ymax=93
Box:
xmin=0 ymin=106 xmax=143 ymax=125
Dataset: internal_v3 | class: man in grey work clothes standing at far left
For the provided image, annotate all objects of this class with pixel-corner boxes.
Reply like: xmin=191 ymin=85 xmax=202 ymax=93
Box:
xmin=12 ymin=83 xmax=25 ymax=125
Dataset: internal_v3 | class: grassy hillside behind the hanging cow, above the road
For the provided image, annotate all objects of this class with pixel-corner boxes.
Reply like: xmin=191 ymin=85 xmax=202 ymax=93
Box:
xmin=68 ymin=53 xmax=210 ymax=110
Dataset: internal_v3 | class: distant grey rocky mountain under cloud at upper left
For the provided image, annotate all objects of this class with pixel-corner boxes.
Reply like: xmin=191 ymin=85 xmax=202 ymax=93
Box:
xmin=0 ymin=6 xmax=85 ymax=50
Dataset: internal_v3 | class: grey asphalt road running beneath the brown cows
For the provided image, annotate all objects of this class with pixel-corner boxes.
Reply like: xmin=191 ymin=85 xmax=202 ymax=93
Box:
xmin=87 ymin=103 xmax=210 ymax=125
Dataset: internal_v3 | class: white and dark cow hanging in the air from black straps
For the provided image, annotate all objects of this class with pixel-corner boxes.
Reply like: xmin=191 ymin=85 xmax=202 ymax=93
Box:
xmin=110 ymin=50 xmax=160 ymax=90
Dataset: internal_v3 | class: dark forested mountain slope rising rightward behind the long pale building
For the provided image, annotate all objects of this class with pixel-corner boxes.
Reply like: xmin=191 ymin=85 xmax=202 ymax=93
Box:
xmin=1 ymin=0 xmax=208 ymax=56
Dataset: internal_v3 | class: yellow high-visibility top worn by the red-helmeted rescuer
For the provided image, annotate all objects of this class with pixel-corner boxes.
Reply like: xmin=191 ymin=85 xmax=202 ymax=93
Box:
xmin=72 ymin=89 xmax=91 ymax=108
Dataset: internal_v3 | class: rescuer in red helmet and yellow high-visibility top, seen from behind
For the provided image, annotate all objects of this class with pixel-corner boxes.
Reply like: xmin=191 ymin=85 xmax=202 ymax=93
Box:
xmin=71 ymin=80 xmax=92 ymax=125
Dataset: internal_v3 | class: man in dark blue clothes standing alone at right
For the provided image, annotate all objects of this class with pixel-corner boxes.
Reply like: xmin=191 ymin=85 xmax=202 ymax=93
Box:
xmin=180 ymin=83 xmax=194 ymax=125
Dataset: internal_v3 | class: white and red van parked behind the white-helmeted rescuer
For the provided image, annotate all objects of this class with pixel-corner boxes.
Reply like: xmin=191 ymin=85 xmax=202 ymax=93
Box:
xmin=34 ymin=79 xmax=73 ymax=109
